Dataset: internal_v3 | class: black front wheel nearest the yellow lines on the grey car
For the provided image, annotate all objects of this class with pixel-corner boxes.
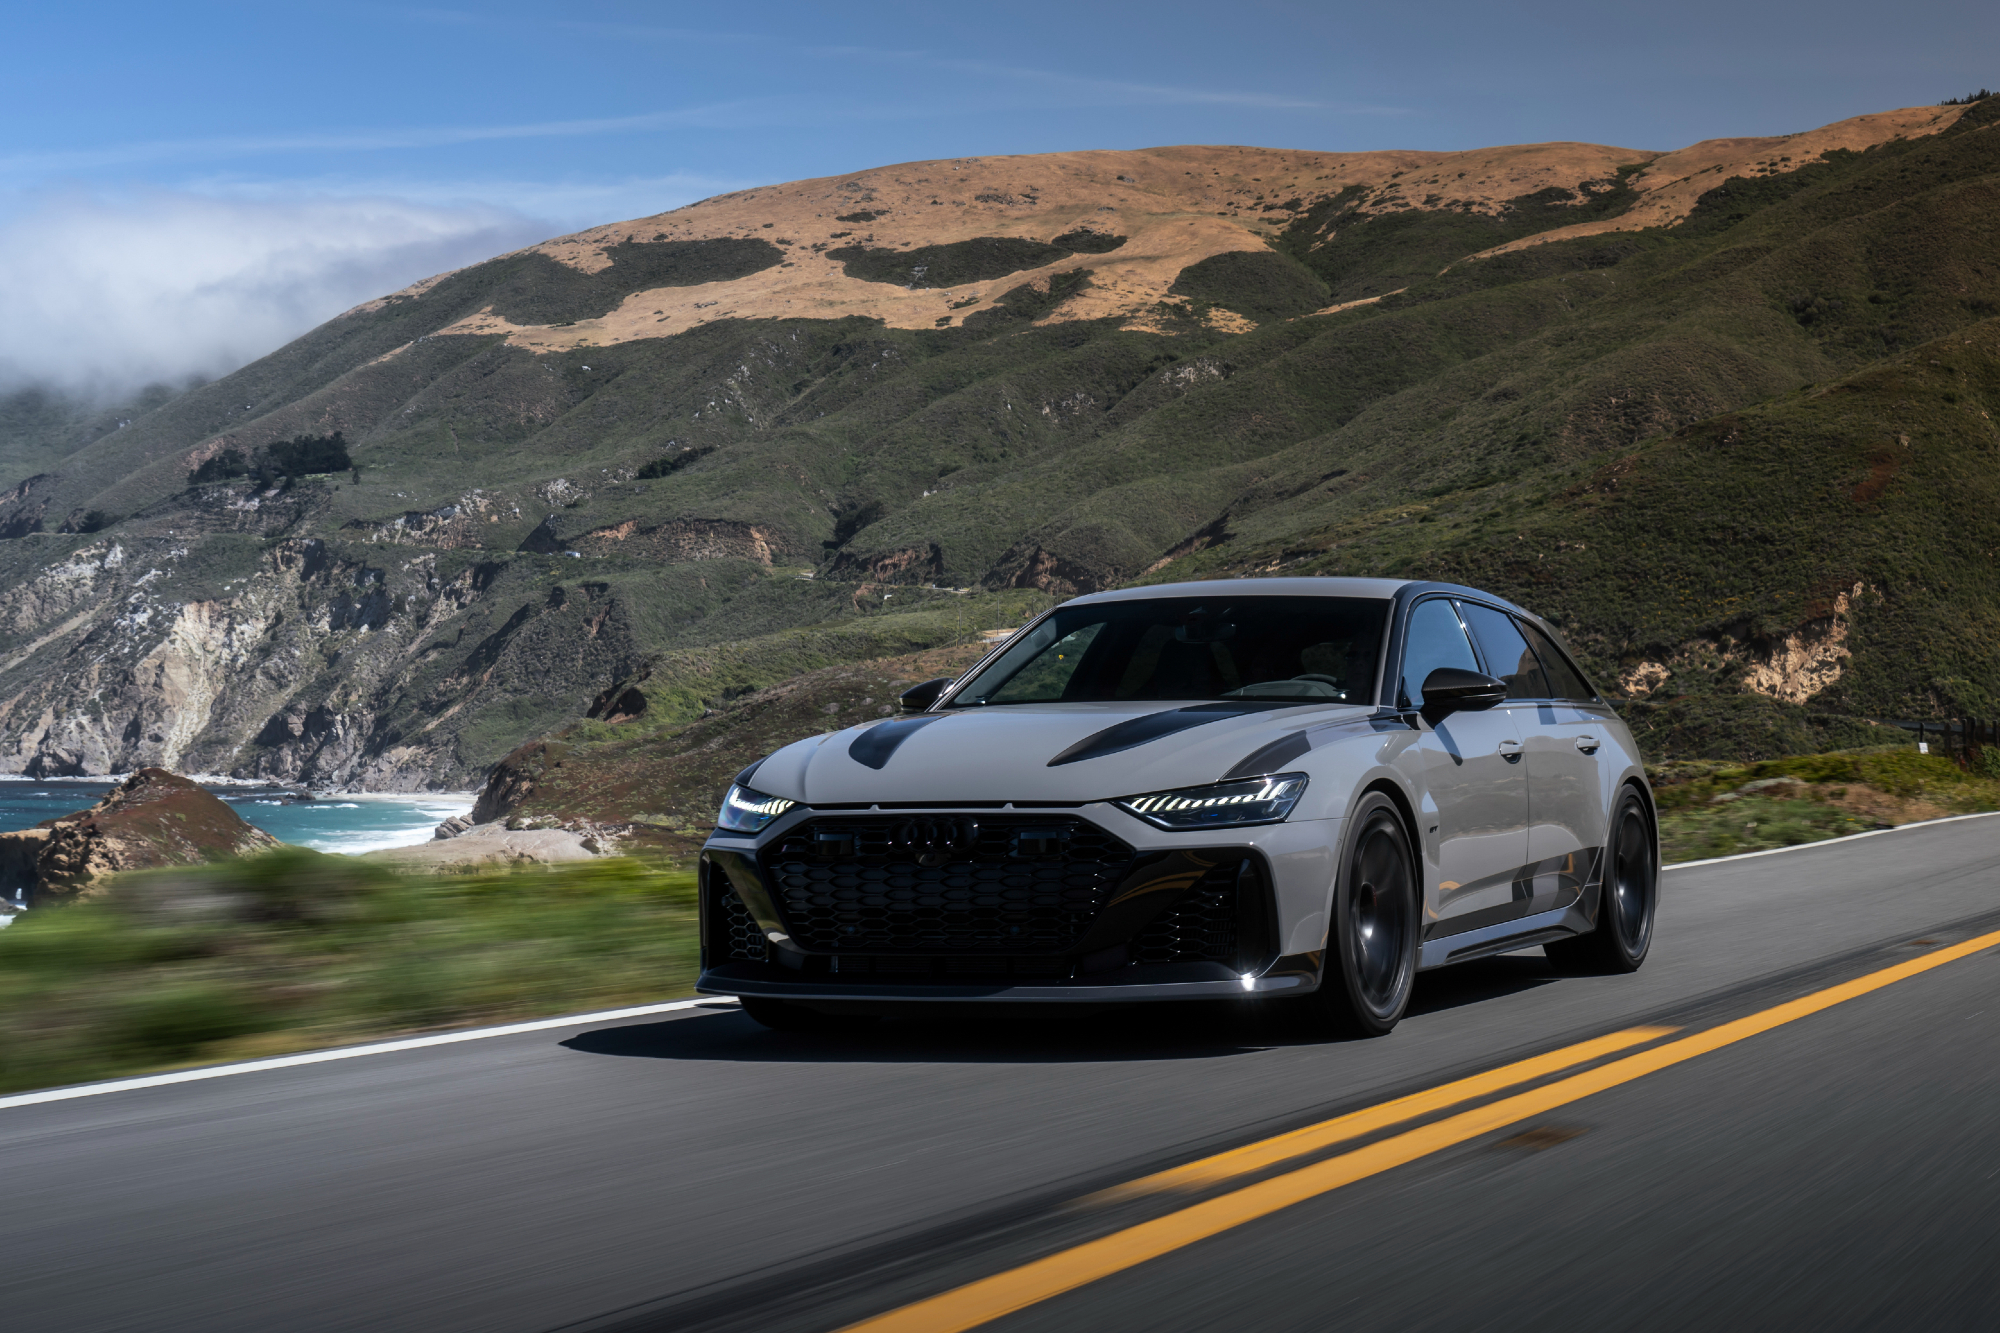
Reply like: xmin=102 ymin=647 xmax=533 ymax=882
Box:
xmin=1312 ymin=793 xmax=1422 ymax=1037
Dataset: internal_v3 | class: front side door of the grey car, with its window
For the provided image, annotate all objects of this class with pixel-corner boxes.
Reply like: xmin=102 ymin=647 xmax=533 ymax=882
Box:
xmin=1402 ymin=596 xmax=1528 ymax=937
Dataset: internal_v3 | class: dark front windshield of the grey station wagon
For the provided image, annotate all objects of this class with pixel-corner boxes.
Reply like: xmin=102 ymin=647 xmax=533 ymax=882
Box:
xmin=948 ymin=596 xmax=1388 ymax=709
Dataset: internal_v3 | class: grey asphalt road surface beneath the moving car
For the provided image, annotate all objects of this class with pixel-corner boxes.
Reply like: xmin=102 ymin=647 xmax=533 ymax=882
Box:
xmin=0 ymin=819 xmax=2000 ymax=1333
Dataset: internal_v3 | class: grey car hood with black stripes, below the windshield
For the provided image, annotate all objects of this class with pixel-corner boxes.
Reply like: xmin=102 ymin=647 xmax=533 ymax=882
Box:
xmin=750 ymin=701 xmax=1368 ymax=805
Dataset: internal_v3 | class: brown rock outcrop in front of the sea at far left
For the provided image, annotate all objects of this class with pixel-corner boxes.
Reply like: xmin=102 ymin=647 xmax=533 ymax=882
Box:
xmin=0 ymin=769 xmax=278 ymax=907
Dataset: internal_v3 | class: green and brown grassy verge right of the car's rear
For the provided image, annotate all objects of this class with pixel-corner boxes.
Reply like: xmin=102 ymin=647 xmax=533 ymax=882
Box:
xmin=1648 ymin=745 xmax=2000 ymax=865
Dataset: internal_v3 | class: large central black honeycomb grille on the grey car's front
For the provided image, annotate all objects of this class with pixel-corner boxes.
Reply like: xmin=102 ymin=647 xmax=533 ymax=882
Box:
xmin=764 ymin=815 xmax=1132 ymax=955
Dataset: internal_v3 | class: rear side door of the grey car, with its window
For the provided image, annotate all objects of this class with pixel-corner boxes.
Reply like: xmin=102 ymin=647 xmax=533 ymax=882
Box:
xmin=1466 ymin=606 xmax=1604 ymax=911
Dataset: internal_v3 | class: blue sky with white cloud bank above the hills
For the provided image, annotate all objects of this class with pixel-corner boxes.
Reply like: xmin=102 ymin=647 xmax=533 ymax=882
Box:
xmin=0 ymin=0 xmax=2000 ymax=386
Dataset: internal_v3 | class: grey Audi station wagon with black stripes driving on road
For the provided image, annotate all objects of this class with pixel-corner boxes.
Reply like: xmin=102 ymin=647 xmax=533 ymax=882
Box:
xmin=700 ymin=578 xmax=1660 ymax=1035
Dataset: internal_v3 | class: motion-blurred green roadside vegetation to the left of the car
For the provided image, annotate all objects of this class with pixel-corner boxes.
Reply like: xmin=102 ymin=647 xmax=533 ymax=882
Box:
xmin=0 ymin=847 xmax=696 ymax=1091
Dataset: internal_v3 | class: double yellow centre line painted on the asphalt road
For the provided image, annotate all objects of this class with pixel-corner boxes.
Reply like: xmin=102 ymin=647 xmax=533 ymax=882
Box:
xmin=842 ymin=931 xmax=2000 ymax=1333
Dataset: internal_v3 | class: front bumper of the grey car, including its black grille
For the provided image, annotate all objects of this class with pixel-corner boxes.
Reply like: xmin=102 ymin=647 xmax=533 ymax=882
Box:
xmin=696 ymin=805 xmax=1338 ymax=1005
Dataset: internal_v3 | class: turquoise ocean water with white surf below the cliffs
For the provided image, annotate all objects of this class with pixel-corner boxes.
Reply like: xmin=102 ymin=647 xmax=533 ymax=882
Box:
xmin=0 ymin=779 xmax=474 ymax=853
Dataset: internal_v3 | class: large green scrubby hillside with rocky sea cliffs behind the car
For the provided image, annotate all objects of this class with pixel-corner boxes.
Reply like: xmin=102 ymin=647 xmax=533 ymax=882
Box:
xmin=0 ymin=100 xmax=2000 ymax=800
